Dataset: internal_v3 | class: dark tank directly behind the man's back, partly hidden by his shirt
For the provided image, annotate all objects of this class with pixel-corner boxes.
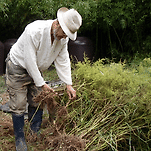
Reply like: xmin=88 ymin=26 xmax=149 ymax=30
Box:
xmin=4 ymin=39 xmax=17 ymax=73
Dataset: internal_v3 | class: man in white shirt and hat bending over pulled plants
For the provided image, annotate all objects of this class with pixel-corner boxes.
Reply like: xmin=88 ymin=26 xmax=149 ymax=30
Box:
xmin=6 ymin=7 xmax=82 ymax=151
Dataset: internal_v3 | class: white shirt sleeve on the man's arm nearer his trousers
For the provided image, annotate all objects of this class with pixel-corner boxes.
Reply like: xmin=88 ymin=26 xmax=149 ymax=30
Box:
xmin=24 ymin=31 xmax=45 ymax=87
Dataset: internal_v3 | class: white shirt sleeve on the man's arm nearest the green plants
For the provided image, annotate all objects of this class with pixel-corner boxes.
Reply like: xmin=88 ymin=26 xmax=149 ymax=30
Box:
xmin=54 ymin=39 xmax=72 ymax=85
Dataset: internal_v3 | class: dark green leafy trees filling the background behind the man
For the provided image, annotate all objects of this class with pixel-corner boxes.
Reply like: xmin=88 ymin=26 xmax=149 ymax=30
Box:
xmin=0 ymin=0 xmax=151 ymax=60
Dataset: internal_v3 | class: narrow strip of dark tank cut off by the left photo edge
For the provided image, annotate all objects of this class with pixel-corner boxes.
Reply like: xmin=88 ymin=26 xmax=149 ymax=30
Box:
xmin=0 ymin=41 xmax=4 ymax=75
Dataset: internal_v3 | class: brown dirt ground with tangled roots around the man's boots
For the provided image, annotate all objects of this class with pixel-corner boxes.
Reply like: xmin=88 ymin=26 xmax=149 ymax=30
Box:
xmin=0 ymin=93 xmax=85 ymax=151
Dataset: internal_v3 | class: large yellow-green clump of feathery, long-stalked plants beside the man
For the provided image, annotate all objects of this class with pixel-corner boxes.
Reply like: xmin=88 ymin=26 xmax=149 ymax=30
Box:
xmin=69 ymin=59 xmax=151 ymax=150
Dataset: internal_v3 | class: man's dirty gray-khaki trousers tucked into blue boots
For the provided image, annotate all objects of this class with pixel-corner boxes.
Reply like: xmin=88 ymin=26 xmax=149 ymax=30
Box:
xmin=6 ymin=55 xmax=42 ymax=114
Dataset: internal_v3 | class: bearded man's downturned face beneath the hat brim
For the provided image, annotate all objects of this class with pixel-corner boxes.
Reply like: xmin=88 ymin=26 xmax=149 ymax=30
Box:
xmin=53 ymin=25 xmax=67 ymax=40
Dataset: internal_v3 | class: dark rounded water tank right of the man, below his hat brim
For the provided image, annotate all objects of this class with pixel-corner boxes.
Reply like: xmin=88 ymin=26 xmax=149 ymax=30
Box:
xmin=68 ymin=37 xmax=94 ymax=61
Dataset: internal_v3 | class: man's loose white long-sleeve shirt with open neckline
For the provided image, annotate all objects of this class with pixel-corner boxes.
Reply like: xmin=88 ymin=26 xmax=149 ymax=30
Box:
xmin=10 ymin=20 xmax=72 ymax=87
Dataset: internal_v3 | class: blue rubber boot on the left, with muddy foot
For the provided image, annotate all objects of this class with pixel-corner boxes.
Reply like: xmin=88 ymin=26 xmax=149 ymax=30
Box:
xmin=12 ymin=113 xmax=27 ymax=151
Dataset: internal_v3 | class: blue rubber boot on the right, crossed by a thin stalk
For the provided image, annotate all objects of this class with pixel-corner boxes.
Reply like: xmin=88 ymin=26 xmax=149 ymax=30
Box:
xmin=28 ymin=105 xmax=43 ymax=134
